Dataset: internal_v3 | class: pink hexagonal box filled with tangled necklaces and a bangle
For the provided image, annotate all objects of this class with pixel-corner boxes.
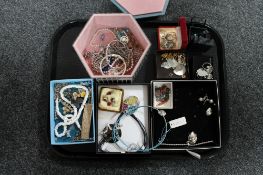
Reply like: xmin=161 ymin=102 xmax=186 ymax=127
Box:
xmin=73 ymin=14 xmax=151 ymax=80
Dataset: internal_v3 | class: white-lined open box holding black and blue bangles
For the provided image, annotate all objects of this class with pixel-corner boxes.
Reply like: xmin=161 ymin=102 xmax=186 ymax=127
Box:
xmin=96 ymin=83 xmax=151 ymax=154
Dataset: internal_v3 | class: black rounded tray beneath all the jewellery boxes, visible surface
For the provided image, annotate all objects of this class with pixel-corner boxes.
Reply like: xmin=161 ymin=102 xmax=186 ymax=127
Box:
xmin=47 ymin=20 xmax=229 ymax=159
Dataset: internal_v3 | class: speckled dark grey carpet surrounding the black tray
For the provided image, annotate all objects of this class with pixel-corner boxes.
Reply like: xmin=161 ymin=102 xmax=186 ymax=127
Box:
xmin=0 ymin=0 xmax=263 ymax=174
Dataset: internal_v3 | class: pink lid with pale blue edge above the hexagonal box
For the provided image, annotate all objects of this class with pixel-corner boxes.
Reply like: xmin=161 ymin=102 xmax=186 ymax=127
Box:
xmin=111 ymin=0 xmax=169 ymax=19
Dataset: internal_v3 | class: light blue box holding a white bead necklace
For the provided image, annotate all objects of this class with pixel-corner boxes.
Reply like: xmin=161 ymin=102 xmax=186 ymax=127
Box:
xmin=50 ymin=79 xmax=95 ymax=145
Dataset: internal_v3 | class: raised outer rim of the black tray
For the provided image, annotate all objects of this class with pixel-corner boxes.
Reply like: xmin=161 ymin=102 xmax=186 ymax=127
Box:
xmin=46 ymin=19 xmax=229 ymax=160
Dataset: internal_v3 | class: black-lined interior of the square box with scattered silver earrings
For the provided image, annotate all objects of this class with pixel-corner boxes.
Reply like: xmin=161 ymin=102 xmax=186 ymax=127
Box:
xmin=151 ymin=80 xmax=221 ymax=150
